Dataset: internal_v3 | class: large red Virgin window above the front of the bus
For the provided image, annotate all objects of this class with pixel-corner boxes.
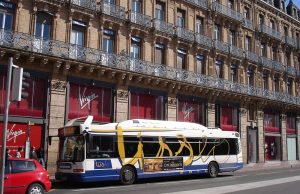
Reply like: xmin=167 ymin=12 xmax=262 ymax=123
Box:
xmin=68 ymin=83 xmax=112 ymax=122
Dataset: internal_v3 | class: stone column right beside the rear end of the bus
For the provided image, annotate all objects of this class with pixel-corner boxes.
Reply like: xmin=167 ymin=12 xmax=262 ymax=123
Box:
xmin=240 ymin=108 xmax=248 ymax=163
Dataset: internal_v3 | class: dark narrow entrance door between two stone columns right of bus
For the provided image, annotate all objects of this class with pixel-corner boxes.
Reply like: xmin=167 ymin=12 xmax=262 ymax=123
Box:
xmin=248 ymin=127 xmax=257 ymax=163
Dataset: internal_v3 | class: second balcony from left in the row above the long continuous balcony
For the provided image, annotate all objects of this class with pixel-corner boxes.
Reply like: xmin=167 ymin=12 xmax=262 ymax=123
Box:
xmin=101 ymin=2 xmax=126 ymax=20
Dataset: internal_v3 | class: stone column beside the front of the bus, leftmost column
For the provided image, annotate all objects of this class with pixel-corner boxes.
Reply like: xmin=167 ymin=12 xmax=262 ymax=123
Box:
xmin=46 ymin=77 xmax=67 ymax=175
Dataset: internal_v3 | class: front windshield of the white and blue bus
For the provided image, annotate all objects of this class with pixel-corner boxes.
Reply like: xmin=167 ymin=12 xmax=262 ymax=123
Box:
xmin=59 ymin=135 xmax=84 ymax=162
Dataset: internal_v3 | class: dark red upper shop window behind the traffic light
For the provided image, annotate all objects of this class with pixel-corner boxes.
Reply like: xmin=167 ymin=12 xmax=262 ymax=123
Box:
xmin=0 ymin=75 xmax=47 ymax=118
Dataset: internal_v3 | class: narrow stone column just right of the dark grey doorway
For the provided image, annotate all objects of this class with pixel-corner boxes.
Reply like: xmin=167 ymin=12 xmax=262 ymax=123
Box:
xmin=257 ymin=110 xmax=265 ymax=162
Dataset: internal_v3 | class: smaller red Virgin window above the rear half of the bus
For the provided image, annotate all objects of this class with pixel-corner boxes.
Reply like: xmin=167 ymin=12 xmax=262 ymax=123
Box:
xmin=178 ymin=99 xmax=204 ymax=124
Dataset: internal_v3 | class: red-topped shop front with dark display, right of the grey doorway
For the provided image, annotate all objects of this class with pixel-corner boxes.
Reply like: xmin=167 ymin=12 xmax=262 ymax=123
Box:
xmin=264 ymin=112 xmax=281 ymax=161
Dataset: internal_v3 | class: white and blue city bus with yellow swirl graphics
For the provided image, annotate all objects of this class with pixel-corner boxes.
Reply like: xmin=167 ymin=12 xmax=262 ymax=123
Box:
xmin=55 ymin=116 xmax=243 ymax=185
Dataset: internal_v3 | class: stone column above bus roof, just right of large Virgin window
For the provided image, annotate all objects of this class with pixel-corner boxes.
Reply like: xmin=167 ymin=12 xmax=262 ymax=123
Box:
xmin=115 ymin=88 xmax=129 ymax=122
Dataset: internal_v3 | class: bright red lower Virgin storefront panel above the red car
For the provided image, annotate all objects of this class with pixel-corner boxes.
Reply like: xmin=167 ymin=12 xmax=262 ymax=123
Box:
xmin=0 ymin=122 xmax=43 ymax=157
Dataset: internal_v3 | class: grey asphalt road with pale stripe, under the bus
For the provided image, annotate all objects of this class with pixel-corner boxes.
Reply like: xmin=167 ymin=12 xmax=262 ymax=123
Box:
xmin=50 ymin=167 xmax=300 ymax=194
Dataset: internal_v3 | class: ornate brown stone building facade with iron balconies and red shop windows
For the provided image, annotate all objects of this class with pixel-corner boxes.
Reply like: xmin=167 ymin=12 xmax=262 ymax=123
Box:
xmin=0 ymin=0 xmax=300 ymax=173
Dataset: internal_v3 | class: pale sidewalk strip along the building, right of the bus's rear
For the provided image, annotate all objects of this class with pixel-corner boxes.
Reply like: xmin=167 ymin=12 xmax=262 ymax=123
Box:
xmin=237 ymin=160 xmax=300 ymax=173
